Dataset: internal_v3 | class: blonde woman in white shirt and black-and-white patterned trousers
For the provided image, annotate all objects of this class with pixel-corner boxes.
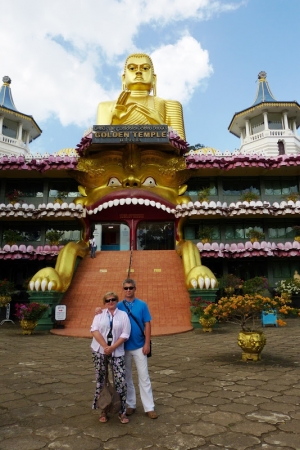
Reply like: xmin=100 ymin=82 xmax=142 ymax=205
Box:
xmin=91 ymin=292 xmax=131 ymax=424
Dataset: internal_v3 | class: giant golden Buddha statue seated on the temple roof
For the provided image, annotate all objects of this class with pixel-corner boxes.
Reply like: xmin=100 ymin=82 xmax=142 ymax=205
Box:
xmin=97 ymin=53 xmax=185 ymax=140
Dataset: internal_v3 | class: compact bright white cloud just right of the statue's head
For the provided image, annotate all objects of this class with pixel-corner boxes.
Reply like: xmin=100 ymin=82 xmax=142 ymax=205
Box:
xmin=151 ymin=36 xmax=213 ymax=103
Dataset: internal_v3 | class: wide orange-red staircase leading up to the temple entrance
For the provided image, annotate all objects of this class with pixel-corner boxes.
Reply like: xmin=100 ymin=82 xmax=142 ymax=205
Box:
xmin=51 ymin=250 xmax=192 ymax=337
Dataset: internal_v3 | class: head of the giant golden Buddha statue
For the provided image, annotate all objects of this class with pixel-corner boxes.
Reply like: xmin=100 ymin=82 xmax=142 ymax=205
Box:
xmin=122 ymin=53 xmax=156 ymax=95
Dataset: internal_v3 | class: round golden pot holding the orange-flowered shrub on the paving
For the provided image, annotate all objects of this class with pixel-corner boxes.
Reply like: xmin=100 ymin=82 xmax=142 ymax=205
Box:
xmin=238 ymin=331 xmax=267 ymax=361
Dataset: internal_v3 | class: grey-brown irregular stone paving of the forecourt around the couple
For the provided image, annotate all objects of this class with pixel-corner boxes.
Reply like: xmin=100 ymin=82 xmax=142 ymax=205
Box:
xmin=0 ymin=319 xmax=300 ymax=450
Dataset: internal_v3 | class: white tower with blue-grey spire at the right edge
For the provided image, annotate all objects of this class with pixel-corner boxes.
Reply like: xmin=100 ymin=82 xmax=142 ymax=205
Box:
xmin=228 ymin=72 xmax=300 ymax=156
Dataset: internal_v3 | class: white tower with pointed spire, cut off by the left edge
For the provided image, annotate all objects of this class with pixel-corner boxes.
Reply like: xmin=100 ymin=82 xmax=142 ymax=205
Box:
xmin=0 ymin=76 xmax=42 ymax=156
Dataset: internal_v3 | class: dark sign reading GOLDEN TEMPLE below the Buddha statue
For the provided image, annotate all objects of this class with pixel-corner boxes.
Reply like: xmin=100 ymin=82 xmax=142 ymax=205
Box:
xmin=93 ymin=125 xmax=169 ymax=144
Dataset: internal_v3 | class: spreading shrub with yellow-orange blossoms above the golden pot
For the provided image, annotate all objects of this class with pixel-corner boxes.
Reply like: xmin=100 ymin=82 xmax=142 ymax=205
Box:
xmin=204 ymin=294 xmax=300 ymax=331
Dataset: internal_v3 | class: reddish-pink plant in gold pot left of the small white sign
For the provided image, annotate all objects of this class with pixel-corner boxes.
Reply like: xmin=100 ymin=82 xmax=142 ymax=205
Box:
xmin=15 ymin=302 xmax=49 ymax=334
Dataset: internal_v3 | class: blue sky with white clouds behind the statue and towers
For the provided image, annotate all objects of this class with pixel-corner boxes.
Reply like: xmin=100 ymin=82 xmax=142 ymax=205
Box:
xmin=0 ymin=0 xmax=300 ymax=153
